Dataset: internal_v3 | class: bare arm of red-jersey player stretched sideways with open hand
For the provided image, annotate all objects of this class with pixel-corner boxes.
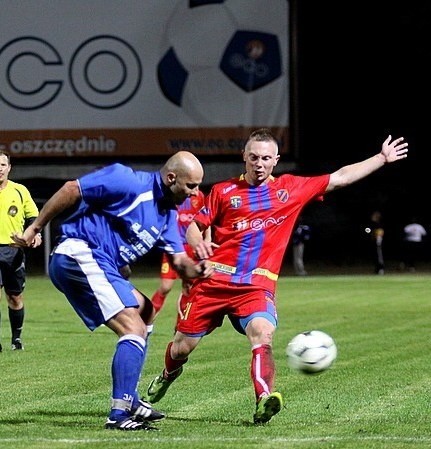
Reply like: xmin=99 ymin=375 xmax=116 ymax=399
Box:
xmin=326 ymin=135 xmax=409 ymax=192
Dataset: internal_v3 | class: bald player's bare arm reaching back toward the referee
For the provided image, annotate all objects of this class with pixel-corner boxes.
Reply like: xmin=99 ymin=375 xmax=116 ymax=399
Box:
xmin=12 ymin=181 xmax=81 ymax=247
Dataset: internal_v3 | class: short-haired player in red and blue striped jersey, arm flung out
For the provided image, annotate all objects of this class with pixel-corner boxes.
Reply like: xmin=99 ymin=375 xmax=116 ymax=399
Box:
xmin=148 ymin=128 xmax=408 ymax=424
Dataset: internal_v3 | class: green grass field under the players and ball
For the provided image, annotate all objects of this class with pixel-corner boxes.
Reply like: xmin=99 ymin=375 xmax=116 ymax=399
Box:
xmin=0 ymin=274 xmax=431 ymax=449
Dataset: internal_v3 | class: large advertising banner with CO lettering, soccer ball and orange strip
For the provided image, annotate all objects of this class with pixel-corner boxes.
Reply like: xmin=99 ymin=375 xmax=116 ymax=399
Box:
xmin=0 ymin=0 xmax=289 ymax=159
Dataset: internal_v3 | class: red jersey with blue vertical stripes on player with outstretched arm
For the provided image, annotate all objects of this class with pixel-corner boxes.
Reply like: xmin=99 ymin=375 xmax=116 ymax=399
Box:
xmin=195 ymin=174 xmax=329 ymax=293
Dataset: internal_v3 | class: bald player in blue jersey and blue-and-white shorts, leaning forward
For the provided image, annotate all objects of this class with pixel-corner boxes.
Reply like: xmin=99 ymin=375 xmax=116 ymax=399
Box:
xmin=13 ymin=151 xmax=213 ymax=430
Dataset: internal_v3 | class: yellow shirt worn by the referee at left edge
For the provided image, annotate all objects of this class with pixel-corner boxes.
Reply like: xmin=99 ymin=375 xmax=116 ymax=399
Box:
xmin=0 ymin=179 xmax=39 ymax=245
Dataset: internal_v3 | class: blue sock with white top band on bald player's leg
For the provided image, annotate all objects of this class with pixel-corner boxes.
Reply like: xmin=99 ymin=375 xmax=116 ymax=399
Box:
xmin=109 ymin=334 xmax=146 ymax=419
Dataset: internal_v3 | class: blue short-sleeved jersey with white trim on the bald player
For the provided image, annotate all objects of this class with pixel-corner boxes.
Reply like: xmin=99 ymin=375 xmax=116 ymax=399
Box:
xmin=60 ymin=164 xmax=184 ymax=267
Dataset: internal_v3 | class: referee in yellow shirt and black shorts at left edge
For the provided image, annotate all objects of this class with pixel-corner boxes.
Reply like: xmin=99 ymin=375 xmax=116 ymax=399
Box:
xmin=0 ymin=150 xmax=42 ymax=352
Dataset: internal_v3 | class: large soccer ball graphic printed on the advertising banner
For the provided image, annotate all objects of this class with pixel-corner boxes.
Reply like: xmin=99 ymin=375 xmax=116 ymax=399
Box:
xmin=157 ymin=0 xmax=288 ymax=126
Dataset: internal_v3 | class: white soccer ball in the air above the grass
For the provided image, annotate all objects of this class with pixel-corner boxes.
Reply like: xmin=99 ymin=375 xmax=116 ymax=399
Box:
xmin=286 ymin=330 xmax=337 ymax=374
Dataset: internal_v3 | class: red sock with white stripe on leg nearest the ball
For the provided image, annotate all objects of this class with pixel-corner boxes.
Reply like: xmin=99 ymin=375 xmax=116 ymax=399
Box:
xmin=250 ymin=345 xmax=275 ymax=400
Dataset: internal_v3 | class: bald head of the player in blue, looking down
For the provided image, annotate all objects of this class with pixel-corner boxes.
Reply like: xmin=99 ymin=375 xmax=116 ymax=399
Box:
xmin=160 ymin=151 xmax=204 ymax=205
